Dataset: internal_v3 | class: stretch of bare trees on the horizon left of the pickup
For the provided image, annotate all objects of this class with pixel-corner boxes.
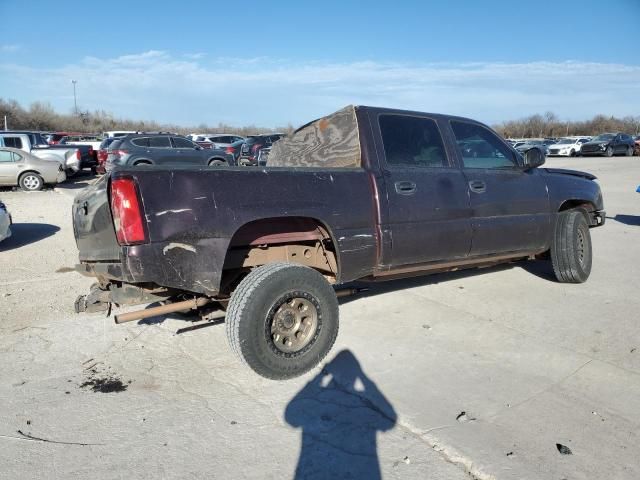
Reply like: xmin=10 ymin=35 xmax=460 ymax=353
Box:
xmin=0 ymin=98 xmax=293 ymax=136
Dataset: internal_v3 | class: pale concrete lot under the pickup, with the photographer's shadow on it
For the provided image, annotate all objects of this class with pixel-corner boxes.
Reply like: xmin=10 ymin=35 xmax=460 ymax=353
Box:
xmin=0 ymin=157 xmax=640 ymax=480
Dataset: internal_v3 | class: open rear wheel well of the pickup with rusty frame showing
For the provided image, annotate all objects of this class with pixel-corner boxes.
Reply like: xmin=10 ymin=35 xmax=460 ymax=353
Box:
xmin=221 ymin=217 xmax=339 ymax=291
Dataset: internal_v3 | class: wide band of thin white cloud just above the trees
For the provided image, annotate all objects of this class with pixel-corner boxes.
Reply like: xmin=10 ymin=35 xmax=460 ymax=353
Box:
xmin=0 ymin=51 xmax=640 ymax=126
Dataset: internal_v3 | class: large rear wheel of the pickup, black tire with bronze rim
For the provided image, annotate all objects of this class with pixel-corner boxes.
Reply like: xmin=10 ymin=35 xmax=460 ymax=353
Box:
xmin=226 ymin=263 xmax=339 ymax=380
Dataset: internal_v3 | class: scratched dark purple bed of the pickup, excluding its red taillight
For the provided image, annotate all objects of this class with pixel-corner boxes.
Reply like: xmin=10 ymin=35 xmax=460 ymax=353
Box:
xmin=73 ymin=167 xmax=377 ymax=295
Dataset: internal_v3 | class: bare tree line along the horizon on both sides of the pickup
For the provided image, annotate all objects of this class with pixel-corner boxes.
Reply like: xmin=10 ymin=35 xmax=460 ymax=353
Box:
xmin=0 ymin=98 xmax=640 ymax=138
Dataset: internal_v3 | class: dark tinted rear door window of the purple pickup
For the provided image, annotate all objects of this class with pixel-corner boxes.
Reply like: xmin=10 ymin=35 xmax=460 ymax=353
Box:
xmin=379 ymin=115 xmax=449 ymax=168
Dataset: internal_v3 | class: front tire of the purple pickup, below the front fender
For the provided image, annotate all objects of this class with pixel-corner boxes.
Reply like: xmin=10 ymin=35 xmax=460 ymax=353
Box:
xmin=550 ymin=210 xmax=592 ymax=283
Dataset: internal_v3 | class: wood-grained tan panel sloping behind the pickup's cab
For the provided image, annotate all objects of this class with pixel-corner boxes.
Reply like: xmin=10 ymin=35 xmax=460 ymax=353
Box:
xmin=267 ymin=105 xmax=361 ymax=168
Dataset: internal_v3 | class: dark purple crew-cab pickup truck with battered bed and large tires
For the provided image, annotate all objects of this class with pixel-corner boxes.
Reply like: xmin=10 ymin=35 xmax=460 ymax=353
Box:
xmin=73 ymin=106 xmax=605 ymax=379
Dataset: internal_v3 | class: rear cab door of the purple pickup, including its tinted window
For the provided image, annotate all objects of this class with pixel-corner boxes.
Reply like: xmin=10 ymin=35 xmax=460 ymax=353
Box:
xmin=371 ymin=113 xmax=471 ymax=268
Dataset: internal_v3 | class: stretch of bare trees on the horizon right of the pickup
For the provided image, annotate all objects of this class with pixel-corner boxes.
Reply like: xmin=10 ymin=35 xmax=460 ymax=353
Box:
xmin=493 ymin=112 xmax=640 ymax=138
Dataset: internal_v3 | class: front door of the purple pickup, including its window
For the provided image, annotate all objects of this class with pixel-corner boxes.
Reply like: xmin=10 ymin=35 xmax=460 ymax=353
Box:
xmin=449 ymin=119 xmax=551 ymax=256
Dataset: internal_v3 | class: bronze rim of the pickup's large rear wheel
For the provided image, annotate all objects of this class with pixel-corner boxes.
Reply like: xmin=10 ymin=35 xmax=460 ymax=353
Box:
xmin=270 ymin=297 xmax=318 ymax=353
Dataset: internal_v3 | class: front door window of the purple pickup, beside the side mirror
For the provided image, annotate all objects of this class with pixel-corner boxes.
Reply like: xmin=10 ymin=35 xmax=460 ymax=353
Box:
xmin=451 ymin=120 xmax=517 ymax=169
